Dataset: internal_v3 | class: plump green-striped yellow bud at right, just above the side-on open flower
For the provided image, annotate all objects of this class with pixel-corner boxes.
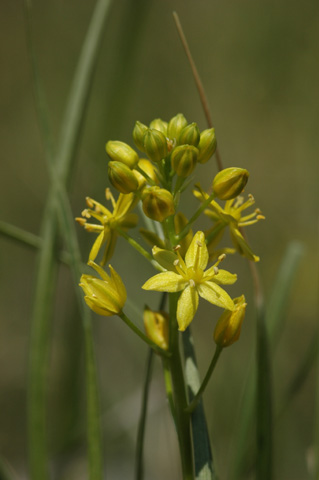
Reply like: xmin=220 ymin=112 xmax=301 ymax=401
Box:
xmin=212 ymin=167 xmax=249 ymax=200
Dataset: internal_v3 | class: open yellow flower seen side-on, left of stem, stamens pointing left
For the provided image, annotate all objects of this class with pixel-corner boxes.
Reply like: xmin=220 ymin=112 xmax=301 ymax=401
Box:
xmin=76 ymin=188 xmax=138 ymax=265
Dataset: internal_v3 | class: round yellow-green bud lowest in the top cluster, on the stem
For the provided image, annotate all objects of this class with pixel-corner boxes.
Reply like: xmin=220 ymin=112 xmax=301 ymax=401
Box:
xmin=142 ymin=187 xmax=175 ymax=222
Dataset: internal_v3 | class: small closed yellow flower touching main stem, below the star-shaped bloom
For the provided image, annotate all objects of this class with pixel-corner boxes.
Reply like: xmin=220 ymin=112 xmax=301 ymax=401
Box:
xmin=143 ymin=307 xmax=169 ymax=350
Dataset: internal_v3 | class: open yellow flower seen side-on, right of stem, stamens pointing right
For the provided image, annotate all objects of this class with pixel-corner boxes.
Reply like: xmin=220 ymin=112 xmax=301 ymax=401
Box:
xmin=194 ymin=190 xmax=265 ymax=262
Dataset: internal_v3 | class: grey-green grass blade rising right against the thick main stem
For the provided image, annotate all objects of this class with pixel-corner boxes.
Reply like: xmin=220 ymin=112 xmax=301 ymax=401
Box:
xmin=182 ymin=328 xmax=217 ymax=480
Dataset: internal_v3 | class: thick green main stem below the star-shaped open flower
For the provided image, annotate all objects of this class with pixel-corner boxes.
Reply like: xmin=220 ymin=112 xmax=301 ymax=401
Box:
xmin=168 ymin=293 xmax=194 ymax=480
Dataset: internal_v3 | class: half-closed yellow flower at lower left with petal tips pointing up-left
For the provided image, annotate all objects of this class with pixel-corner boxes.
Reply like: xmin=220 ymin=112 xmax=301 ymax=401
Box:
xmin=80 ymin=262 xmax=126 ymax=317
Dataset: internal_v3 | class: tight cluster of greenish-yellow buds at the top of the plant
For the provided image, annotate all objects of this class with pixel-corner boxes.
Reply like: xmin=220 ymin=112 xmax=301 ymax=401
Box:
xmin=106 ymin=113 xmax=216 ymax=222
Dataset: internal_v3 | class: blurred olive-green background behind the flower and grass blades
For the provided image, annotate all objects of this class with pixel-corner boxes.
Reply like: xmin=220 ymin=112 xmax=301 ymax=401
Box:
xmin=0 ymin=0 xmax=319 ymax=480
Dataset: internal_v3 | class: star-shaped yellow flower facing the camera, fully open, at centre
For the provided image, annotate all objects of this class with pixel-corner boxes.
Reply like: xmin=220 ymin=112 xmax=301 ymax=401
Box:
xmin=142 ymin=232 xmax=237 ymax=331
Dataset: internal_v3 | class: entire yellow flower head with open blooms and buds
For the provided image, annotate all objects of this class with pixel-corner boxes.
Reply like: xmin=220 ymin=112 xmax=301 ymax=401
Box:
xmin=76 ymin=114 xmax=264 ymax=350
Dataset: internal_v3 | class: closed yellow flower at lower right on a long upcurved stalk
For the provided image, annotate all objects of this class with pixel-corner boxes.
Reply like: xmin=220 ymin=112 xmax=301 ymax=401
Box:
xmin=214 ymin=295 xmax=247 ymax=348
